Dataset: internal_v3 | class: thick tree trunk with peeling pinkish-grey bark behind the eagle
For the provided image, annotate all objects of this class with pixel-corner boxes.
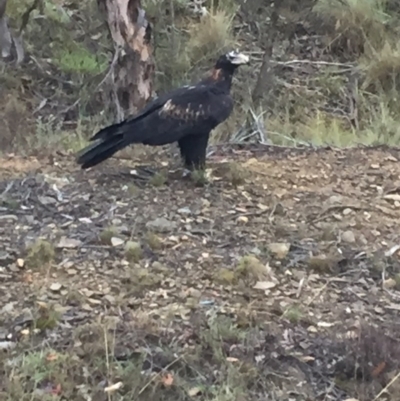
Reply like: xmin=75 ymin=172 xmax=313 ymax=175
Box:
xmin=97 ymin=0 xmax=154 ymax=120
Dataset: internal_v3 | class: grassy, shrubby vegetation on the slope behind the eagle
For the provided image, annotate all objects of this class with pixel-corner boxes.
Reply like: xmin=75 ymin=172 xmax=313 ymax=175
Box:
xmin=0 ymin=0 xmax=400 ymax=155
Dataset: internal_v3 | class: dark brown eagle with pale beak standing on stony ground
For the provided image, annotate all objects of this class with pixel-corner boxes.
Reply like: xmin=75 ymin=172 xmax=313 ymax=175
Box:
xmin=77 ymin=51 xmax=249 ymax=169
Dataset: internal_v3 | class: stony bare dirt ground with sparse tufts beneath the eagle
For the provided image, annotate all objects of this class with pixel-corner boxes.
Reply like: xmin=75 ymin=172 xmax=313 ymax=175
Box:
xmin=0 ymin=147 xmax=400 ymax=401
